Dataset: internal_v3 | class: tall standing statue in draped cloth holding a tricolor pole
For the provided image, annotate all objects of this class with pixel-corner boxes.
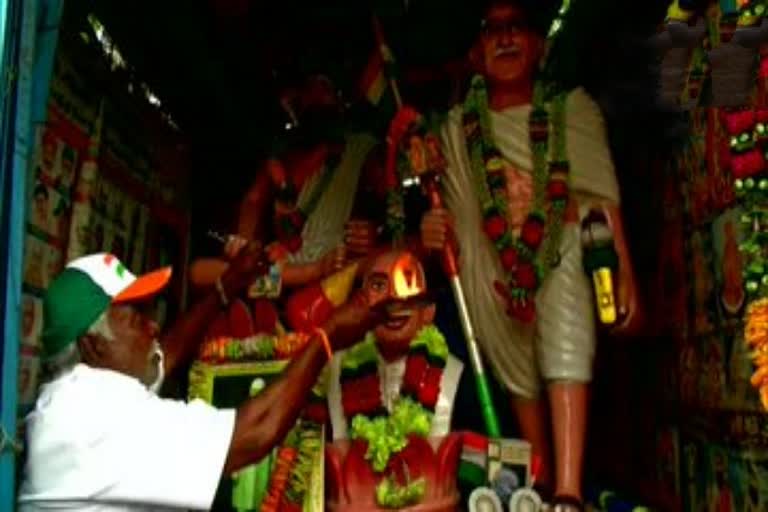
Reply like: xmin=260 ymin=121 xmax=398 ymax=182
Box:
xmin=421 ymin=0 xmax=634 ymax=511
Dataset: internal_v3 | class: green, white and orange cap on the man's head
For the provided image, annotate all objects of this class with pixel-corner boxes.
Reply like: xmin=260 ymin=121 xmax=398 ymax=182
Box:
xmin=42 ymin=253 xmax=171 ymax=357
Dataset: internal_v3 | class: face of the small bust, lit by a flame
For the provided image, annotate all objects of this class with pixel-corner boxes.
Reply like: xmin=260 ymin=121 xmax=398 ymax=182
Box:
xmin=363 ymin=252 xmax=435 ymax=357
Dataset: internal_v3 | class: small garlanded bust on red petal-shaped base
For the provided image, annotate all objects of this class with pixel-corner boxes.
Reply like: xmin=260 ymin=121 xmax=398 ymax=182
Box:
xmin=326 ymin=251 xmax=463 ymax=511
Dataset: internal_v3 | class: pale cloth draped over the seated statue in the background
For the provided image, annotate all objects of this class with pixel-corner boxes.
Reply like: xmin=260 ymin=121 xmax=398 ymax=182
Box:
xmin=289 ymin=134 xmax=376 ymax=263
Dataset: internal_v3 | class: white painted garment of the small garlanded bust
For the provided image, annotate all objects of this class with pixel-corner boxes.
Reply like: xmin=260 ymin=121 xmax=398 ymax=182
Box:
xmin=328 ymin=350 xmax=464 ymax=440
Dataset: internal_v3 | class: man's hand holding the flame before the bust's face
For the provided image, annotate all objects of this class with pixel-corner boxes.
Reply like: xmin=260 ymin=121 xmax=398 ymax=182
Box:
xmin=323 ymin=291 xmax=385 ymax=350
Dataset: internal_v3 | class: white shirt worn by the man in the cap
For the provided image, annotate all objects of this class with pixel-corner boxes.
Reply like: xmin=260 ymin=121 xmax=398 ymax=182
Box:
xmin=19 ymin=364 xmax=235 ymax=512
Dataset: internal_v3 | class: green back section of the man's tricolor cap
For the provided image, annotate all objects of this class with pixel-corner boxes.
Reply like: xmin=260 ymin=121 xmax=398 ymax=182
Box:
xmin=42 ymin=268 xmax=112 ymax=358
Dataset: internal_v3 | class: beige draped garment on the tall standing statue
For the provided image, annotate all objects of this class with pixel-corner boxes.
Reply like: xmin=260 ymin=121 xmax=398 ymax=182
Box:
xmin=443 ymin=89 xmax=619 ymax=398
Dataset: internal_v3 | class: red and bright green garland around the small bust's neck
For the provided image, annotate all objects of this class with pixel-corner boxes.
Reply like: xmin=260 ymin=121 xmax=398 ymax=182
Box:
xmin=341 ymin=325 xmax=448 ymax=508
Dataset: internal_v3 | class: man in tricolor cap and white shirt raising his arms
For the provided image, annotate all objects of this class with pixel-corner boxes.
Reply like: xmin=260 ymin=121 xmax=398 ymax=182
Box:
xmin=19 ymin=248 xmax=374 ymax=511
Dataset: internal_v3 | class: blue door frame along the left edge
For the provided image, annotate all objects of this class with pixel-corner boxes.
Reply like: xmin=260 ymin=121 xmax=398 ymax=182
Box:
xmin=0 ymin=0 xmax=63 ymax=511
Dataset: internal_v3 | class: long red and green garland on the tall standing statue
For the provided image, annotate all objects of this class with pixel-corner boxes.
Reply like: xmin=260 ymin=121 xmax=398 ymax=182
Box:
xmin=464 ymin=76 xmax=570 ymax=322
